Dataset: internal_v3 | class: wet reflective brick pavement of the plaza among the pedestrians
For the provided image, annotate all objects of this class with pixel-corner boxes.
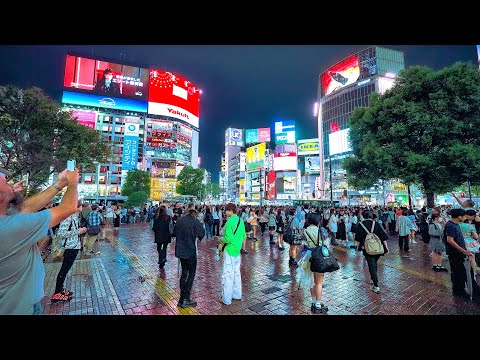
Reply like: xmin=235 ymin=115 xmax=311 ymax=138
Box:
xmin=42 ymin=224 xmax=480 ymax=316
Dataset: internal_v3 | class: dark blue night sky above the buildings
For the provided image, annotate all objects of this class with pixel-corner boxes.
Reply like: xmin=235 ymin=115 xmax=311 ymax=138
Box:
xmin=0 ymin=45 xmax=477 ymax=182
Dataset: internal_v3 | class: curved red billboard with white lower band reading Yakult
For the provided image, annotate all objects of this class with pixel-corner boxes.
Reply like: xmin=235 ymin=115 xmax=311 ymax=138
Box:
xmin=148 ymin=69 xmax=200 ymax=128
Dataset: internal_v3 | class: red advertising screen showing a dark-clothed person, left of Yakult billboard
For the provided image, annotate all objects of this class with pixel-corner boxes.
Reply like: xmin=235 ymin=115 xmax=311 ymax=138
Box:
xmin=63 ymin=55 xmax=148 ymax=101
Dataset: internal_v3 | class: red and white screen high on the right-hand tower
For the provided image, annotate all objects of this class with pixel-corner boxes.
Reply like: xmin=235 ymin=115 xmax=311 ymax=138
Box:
xmin=322 ymin=55 xmax=360 ymax=96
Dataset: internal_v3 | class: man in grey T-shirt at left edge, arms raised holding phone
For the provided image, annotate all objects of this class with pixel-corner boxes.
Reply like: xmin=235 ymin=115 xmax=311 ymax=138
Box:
xmin=0 ymin=168 xmax=79 ymax=315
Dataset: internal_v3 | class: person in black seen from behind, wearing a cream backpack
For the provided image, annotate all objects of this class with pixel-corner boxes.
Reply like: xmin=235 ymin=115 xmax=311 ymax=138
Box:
xmin=355 ymin=210 xmax=389 ymax=294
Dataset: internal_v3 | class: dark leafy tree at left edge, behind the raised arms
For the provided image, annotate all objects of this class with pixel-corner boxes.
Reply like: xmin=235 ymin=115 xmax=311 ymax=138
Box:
xmin=0 ymin=86 xmax=111 ymax=190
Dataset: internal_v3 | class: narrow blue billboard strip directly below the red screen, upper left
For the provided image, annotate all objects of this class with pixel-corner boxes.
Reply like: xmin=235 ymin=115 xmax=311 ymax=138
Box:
xmin=62 ymin=91 xmax=148 ymax=113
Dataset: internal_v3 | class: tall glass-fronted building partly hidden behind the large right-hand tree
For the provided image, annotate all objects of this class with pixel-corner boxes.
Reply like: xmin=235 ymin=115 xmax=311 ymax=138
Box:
xmin=317 ymin=46 xmax=420 ymax=204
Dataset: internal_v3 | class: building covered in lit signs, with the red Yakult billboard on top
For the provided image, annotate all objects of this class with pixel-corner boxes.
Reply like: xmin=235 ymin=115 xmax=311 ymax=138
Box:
xmin=62 ymin=54 xmax=201 ymax=200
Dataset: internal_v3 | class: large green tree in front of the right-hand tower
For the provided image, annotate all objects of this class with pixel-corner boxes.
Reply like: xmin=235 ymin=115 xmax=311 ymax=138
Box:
xmin=343 ymin=63 xmax=480 ymax=207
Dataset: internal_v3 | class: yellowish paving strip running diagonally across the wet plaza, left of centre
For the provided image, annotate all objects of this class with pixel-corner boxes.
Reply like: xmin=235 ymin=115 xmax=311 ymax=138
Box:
xmin=109 ymin=234 xmax=200 ymax=315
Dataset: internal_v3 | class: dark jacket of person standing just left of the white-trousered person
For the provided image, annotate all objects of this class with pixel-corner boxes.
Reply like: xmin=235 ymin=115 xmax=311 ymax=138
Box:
xmin=172 ymin=215 xmax=205 ymax=259
